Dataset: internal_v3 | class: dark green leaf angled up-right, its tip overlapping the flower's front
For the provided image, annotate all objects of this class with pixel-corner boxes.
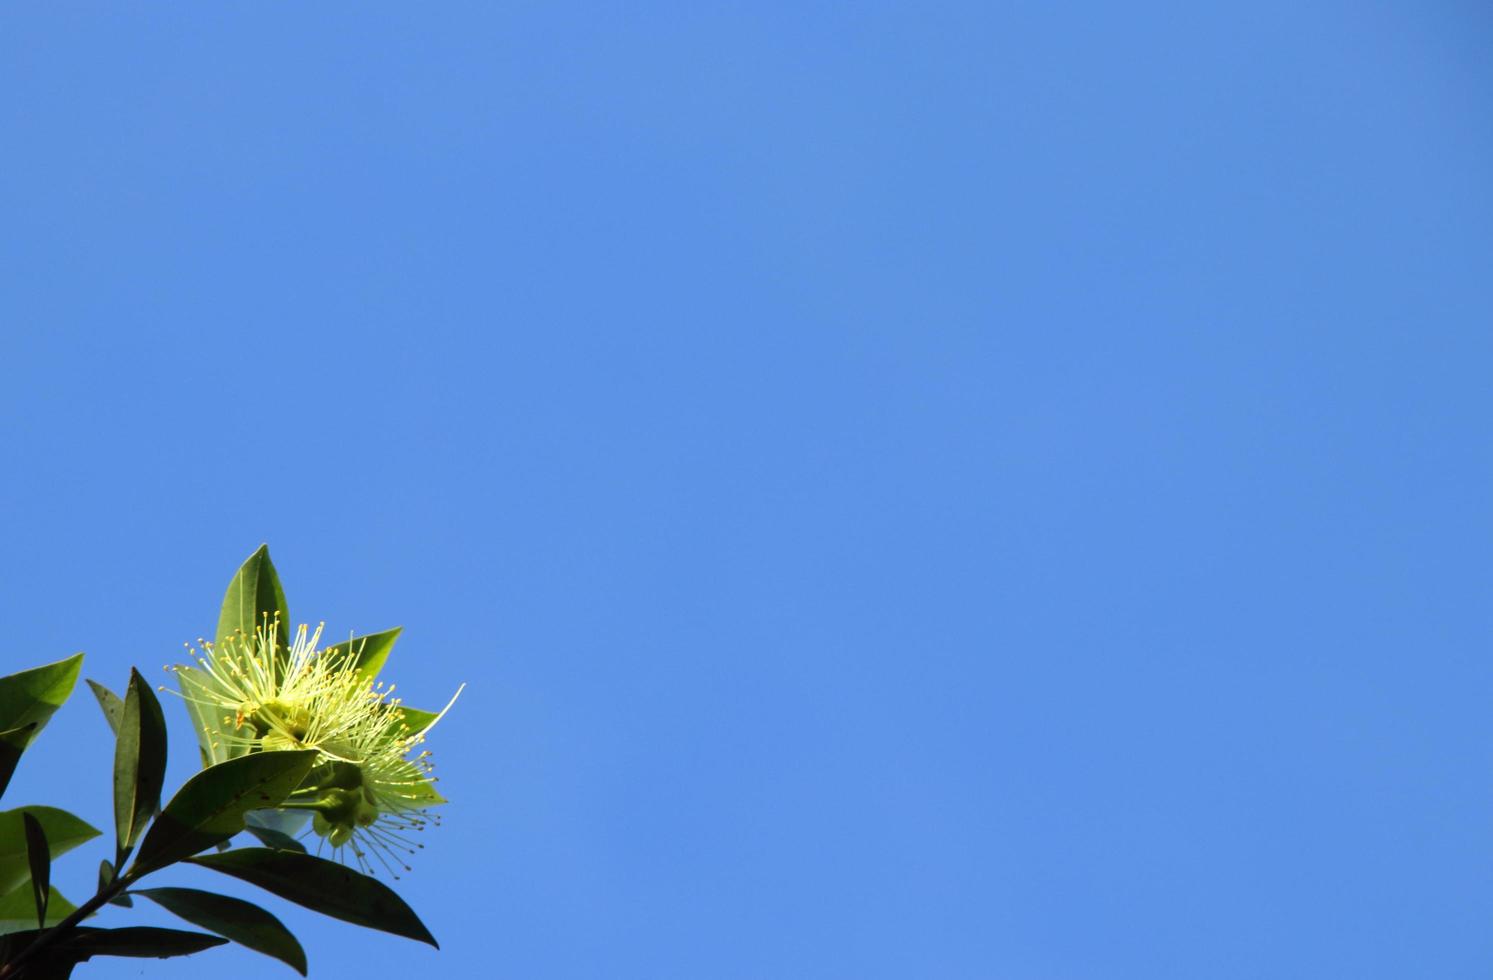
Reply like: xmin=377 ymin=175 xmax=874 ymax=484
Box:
xmin=131 ymin=748 xmax=317 ymax=874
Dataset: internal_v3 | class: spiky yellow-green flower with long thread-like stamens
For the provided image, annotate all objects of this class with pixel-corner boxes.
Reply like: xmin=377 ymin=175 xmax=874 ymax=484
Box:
xmin=169 ymin=618 xmax=464 ymax=878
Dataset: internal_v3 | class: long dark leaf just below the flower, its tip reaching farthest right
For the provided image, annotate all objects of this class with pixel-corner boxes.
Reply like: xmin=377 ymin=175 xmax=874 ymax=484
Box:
xmin=190 ymin=847 xmax=439 ymax=949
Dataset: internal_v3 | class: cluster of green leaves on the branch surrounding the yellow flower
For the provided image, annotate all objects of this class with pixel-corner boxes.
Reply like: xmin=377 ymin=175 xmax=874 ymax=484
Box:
xmin=0 ymin=547 xmax=436 ymax=980
